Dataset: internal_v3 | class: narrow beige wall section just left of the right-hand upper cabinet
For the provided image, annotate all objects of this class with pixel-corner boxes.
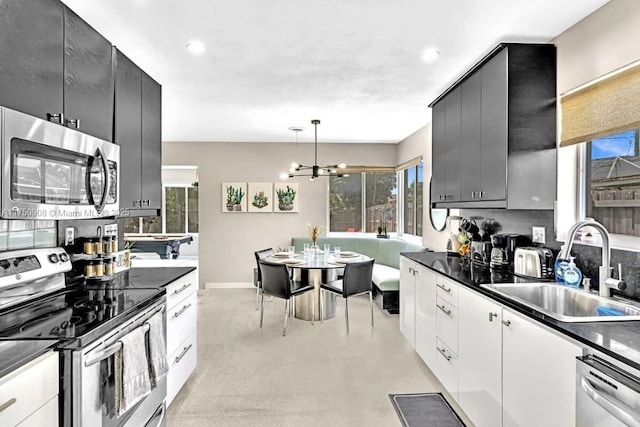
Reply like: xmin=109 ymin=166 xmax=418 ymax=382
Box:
xmin=397 ymin=123 xmax=448 ymax=251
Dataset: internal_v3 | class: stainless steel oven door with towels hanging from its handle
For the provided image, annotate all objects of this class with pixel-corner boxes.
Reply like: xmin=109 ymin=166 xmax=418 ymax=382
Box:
xmin=63 ymin=299 xmax=167 ymax=427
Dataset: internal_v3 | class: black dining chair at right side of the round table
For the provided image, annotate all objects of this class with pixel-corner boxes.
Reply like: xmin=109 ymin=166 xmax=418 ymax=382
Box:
xmin=320 ymin=259 xmax=375 ymax=335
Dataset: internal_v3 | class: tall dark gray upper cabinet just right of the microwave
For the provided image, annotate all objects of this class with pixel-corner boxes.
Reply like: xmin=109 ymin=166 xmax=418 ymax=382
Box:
xmin=114 ymin=49 xmax=162 ymax=216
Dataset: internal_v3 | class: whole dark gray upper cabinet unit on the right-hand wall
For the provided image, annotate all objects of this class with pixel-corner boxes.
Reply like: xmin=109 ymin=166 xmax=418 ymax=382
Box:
xmin=430 ymin=43 xmax=556 ymax=209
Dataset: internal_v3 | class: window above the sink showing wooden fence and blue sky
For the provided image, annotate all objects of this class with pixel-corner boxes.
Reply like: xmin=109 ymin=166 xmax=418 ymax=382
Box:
xmin=585 ymin=129 xmax=640 ymax=236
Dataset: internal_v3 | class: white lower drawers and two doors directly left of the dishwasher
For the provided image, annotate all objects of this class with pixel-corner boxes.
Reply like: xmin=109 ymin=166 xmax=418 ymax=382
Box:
xmin=424 ymin=273 xmax=582 ymax=427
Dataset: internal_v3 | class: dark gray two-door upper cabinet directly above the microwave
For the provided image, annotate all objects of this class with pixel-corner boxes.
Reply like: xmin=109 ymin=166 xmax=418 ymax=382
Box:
xmin=0 ymin=0 xmax=113 ymax=141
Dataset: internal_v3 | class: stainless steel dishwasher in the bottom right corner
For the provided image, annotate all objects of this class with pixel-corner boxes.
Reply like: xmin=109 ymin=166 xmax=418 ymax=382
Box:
xmin=576 ymin=354 xmax=640 ymax=427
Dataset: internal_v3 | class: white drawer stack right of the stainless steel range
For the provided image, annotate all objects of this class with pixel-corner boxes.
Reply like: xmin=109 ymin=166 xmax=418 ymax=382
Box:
xmin=166 ymin=270 xmax=198 ymax=407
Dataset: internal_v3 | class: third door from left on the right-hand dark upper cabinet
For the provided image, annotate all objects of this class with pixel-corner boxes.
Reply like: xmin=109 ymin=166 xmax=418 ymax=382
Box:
xmin=459 ymin=72 xmax=483 ymax=201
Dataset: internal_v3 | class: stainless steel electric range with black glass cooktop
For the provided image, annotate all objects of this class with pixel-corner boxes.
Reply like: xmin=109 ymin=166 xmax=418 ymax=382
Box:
xmin=0 ymin=248 xmax=166 ymax=427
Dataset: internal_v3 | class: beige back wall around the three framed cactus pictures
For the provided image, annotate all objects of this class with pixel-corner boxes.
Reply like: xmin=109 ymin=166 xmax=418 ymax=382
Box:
xmin=162 ymin=142 xmax=396 ymax=286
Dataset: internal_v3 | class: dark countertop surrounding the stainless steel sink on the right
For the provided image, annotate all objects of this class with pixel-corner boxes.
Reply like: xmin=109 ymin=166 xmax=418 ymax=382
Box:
xmin=402 ymin=252 xmax=640 ymax=369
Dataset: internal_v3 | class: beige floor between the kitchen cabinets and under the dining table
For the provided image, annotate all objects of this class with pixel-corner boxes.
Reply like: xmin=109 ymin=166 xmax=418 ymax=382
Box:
xmin=167 ymin=289 xmax=464 ymax=427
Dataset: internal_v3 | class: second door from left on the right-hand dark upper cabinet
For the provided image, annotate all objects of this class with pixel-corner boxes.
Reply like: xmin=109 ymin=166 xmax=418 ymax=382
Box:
xmin=444 ymin=87 xmax=462 ymax=202
